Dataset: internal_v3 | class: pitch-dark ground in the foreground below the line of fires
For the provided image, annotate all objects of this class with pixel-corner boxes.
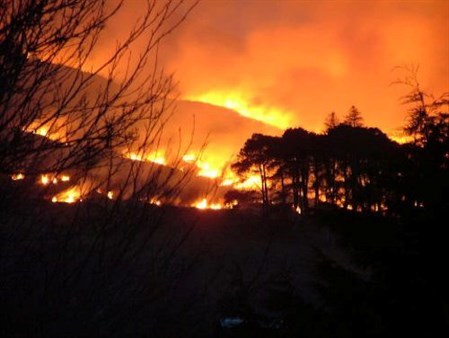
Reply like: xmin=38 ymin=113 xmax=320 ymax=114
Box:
xmin=0 ymin=201 xmax=447 ymax=337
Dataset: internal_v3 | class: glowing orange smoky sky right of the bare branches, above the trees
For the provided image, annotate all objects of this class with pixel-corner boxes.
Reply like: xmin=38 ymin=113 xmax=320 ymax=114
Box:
xmin=158 ymin=0 xmax=449 ymax=132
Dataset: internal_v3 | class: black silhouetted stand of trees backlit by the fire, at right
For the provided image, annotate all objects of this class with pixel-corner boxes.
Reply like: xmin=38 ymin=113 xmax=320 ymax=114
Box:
xmin=227 ymin=83 xmax=449 ymax=215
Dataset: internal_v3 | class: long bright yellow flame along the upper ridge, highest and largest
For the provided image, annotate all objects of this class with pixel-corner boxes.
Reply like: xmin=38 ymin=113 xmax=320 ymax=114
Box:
xmin=188 ymin=91 xmax=291 ymax=129
